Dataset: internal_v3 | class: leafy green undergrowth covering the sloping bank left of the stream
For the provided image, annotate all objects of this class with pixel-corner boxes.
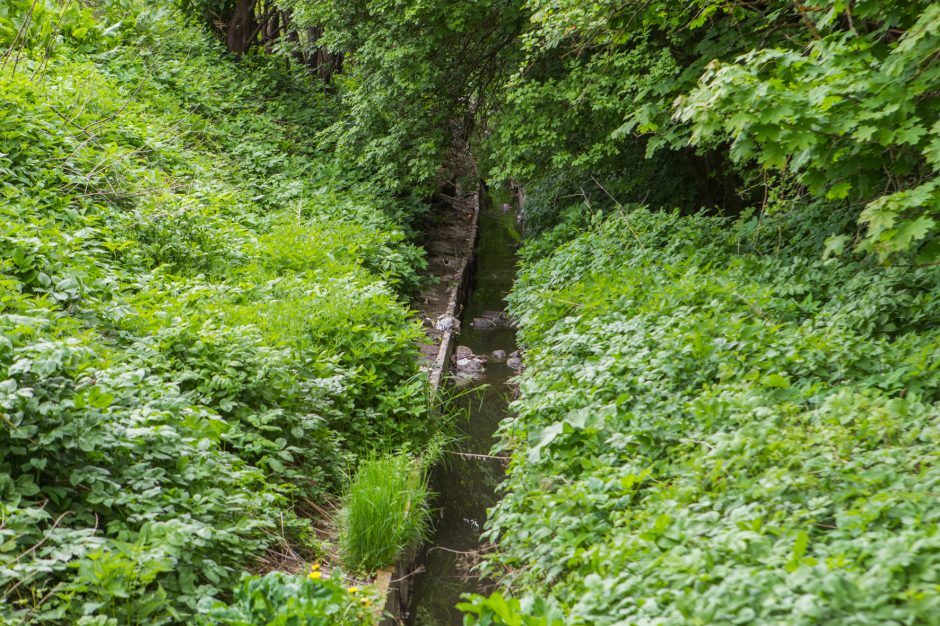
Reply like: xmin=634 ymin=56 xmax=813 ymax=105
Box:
xmin=0 ymin=0 xmax=433 ymax=626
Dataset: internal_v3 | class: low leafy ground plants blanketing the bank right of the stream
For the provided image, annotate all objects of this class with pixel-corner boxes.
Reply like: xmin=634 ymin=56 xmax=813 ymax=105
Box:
xmin=473 ymin=208 xmax=940 ymax=625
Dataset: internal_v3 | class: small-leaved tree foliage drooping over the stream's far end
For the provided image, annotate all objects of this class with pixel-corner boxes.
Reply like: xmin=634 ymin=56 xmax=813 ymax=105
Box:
xmin=287 ymin=0 xmax=525 ymax=191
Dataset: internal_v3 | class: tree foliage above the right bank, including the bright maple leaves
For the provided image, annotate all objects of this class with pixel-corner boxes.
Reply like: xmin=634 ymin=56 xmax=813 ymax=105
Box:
xmin=489 ymin=0 xmax=940 ymax=263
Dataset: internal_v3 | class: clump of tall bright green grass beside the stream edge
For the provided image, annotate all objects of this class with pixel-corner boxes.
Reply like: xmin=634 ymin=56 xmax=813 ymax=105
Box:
xmin=339 ymin=453 xmax=431 ymax=571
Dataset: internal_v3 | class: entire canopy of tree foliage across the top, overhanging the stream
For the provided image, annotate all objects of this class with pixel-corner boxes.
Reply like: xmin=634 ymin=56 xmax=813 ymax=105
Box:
xmin=184 ymin=0 xmax=940 ymax=256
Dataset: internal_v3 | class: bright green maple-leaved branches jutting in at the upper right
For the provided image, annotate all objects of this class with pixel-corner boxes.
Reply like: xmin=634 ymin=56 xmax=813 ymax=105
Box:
xmin=677 ymin=2 xmax=940 ymax=262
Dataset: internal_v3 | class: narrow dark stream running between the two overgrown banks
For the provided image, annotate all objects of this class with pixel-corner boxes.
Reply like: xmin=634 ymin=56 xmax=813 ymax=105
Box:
xmin=410 ymin=190 xmax=520 ymax=626
